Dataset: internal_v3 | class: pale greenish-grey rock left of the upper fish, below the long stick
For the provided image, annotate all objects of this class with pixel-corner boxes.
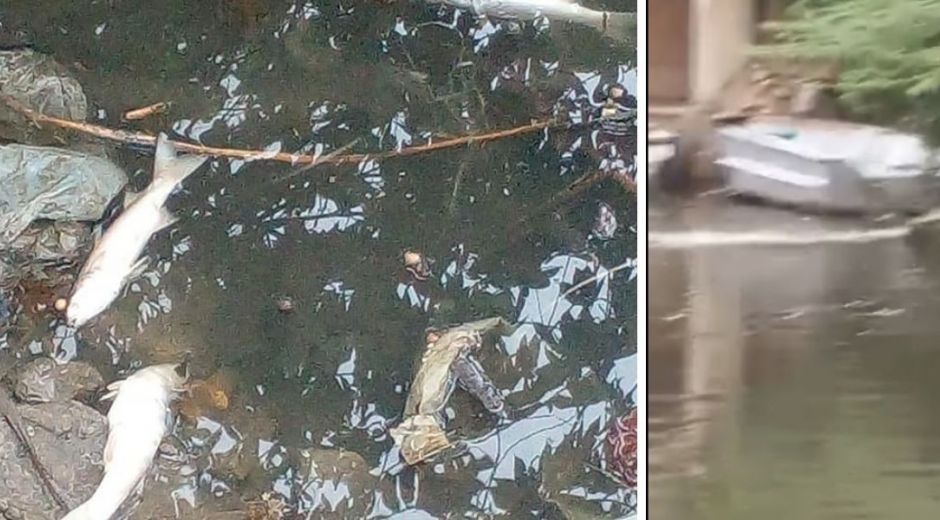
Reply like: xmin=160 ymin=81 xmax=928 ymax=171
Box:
xmin=0 ymin=144 xmax=127 ymax=250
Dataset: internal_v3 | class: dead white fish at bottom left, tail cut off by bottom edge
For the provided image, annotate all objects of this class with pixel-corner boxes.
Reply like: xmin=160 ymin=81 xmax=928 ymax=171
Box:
xmin=63 ymin=364 xmax=188 ymax=520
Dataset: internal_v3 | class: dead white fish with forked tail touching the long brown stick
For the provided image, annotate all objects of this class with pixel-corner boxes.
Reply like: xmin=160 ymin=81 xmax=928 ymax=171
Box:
xmin=66 ymin=134 xmax=206 ymax=327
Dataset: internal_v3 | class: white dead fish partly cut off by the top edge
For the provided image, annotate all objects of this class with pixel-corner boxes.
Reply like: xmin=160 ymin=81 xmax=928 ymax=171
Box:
xmin=437 ymin=0 xmax=636 ymax=40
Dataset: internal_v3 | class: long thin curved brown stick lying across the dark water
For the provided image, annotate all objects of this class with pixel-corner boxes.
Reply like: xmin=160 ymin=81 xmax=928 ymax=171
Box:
xmin=0 ymin=95 xmax=561 ymax=165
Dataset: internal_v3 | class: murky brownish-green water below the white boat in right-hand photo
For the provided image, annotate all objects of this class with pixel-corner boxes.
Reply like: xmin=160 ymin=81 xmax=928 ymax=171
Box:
xmin=649 ymin=199 xmax=940 ymax=519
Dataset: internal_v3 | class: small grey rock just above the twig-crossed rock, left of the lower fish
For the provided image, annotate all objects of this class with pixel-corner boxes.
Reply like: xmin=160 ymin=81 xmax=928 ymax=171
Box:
xmin=15 ymin=358 xmax=104 ymax=403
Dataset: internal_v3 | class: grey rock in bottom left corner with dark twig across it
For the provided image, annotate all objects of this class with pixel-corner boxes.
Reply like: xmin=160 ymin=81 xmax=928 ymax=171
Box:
xmin=0 ymin=396 xmax=108 ymax=520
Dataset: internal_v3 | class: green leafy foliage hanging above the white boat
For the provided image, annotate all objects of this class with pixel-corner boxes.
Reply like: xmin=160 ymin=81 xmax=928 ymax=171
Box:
xmin=760 ymin=0 xmax=940 ymax=140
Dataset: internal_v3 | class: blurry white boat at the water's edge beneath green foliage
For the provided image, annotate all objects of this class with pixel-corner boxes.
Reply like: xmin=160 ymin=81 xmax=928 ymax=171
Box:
xmin=716 ymin=117 xmax=940 ymax=213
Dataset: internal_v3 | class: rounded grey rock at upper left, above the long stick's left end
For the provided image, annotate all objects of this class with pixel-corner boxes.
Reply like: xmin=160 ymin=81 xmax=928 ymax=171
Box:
xmin=0 ymin=49 xmax=88 ymax=121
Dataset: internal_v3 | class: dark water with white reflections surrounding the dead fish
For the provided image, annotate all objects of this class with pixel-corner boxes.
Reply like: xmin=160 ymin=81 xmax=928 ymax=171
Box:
xmin=0 ymin=0 xmax=636 ymax=518
